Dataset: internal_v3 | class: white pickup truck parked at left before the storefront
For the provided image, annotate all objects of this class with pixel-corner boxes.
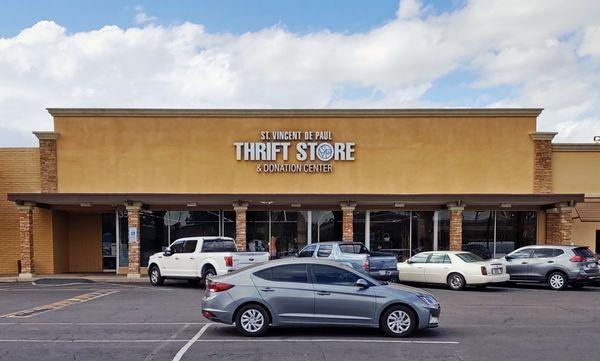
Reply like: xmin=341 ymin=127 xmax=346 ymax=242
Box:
xmin=148 ymin=237 xmax=269 ymax=286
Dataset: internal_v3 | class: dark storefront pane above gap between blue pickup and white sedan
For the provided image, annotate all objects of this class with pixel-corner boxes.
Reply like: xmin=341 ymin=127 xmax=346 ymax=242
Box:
xmin=369 ymin=211 xmax=410 ymax=257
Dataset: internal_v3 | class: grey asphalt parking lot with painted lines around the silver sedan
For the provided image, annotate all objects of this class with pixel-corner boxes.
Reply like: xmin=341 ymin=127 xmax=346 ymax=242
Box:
xmin=0 ymin=280 xmax=600 ymax=361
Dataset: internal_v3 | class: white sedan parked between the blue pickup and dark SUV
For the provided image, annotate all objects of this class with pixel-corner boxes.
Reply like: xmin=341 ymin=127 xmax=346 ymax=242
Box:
xmin=398 ymin=251 xmax=510 ymax=290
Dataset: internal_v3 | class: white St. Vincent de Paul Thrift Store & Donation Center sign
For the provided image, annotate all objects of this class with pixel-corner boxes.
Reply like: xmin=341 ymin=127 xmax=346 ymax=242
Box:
xmin=233 ymin=130 xmax=355 ymax=173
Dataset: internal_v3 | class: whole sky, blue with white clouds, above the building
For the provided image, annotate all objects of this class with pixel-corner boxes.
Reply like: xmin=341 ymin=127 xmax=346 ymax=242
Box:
xmin=0 ymin=0 xmax=600 ymax=147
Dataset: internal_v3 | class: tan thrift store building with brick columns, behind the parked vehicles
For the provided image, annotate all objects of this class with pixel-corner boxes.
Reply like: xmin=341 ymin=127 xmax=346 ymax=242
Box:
xmin=0 ymin=109 xmax=600 ymax=277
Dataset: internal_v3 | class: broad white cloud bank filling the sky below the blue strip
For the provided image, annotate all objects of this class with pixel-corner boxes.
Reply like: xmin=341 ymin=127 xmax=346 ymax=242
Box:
xmin=0 ymin=0 xmax=600 ymax=145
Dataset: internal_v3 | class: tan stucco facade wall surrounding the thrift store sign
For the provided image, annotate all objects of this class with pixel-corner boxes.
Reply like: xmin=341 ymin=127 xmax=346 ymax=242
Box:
xmin=55 ymin=116 xmax=535 ymax=194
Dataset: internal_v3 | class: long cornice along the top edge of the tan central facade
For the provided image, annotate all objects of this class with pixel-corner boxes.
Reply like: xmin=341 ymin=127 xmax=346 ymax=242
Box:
xmin=46 ymin=108 xmax=543 ymax=118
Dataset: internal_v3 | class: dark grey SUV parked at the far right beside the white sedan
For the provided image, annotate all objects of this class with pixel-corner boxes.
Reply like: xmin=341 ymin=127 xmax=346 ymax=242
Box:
xmin=502 ymin=245 xmax=600 ymax=290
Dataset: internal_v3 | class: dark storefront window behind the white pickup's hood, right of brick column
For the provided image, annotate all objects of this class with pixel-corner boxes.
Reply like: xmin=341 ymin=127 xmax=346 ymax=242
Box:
xmin=140 ymin=211 xmax=169 ymax=267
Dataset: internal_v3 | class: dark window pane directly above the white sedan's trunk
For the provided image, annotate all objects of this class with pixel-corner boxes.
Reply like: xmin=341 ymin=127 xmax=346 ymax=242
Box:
xmin=462 ymin=211 xmax=494 ymax=259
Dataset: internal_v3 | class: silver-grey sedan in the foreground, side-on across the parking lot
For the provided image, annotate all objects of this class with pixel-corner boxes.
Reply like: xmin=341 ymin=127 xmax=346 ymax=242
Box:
xmin=202 ymin=258 xmax=440 ymax=337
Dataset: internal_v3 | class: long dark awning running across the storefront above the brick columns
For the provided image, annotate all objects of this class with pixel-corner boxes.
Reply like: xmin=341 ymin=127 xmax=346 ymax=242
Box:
xmin=7 ymin=193 xmax=584 ymax=208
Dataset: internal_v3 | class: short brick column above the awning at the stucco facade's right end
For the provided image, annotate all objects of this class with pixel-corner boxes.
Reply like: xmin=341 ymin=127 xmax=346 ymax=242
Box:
xmin=529 ymin=132 xmax=558 ymax=193
